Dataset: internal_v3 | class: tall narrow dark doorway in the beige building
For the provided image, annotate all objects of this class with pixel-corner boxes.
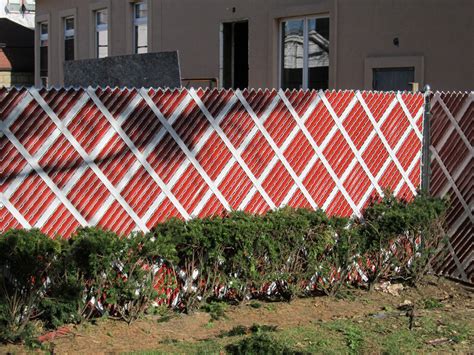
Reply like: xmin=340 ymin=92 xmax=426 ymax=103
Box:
xmin=222 ymin=21 xmax=249 ymax=89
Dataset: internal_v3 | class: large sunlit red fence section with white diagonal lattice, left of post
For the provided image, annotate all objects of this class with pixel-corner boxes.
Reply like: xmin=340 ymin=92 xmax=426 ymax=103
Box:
xmin=0 ymin=88 xmax=423 ymax=237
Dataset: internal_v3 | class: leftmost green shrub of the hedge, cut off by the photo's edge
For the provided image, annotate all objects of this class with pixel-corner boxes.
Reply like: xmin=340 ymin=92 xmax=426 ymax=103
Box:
xmin=0 ymin=229 xmax=61 ymax=342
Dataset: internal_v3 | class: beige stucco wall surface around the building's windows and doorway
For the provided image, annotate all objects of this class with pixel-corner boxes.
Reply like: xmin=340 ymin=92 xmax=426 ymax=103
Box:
xmin=37 ymin=0 xmax=474 ymax=90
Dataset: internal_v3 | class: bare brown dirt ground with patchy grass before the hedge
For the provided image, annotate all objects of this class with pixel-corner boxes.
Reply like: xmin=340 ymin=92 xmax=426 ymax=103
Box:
xmin=0 ymin=277 xmax=474 ymax=354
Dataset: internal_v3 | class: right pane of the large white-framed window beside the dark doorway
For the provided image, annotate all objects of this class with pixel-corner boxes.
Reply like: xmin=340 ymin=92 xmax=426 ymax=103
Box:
xmin=308 ymin=18 xmax=329 ymax=90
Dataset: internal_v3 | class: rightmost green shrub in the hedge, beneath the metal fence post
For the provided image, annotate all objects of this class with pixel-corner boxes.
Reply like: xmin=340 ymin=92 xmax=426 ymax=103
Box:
xmin=357 ymin=194 xmax=447 ymax=286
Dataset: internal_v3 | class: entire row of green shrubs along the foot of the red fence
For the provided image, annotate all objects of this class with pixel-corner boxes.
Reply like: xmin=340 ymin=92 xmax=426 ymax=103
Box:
xmin=0 ymin=194 xmax=446 ymax=344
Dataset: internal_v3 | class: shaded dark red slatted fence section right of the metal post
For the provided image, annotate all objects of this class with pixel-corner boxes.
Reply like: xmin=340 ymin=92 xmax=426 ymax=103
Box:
xmin=430 ymin=91 xmax=474 ymax=284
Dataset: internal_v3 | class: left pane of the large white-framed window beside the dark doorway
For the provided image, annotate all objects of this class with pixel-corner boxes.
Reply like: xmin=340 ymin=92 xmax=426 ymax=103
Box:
xmin=281 ymin=20 xmax=304 ymax=89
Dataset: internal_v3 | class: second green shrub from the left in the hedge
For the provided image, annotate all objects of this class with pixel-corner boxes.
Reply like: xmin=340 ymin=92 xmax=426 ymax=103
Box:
xmin=68 ymin=228 xmax=167 ymax=322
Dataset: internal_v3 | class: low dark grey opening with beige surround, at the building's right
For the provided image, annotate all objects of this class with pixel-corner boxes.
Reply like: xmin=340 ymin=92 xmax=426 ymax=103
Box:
xmin=372 ymin=67 xmax=415 ymax=91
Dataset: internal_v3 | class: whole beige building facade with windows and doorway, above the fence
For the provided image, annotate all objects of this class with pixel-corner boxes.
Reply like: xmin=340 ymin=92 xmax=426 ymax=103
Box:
xmin=35 ymin=0 xmax=474 ymax=90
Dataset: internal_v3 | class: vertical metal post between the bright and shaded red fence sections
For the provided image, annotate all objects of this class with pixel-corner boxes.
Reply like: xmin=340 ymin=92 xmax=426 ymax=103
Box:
xmin=421 ymin=85 xmax=432 ymax=194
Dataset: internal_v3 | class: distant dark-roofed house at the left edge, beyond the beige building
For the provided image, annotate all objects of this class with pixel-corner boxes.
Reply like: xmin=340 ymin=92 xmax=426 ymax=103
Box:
xmin=0 ymin=0 xmax=35 ymax=87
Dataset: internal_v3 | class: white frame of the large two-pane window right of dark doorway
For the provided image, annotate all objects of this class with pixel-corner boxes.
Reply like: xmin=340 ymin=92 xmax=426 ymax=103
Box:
xmin=278 ymin=14 xmax=331 ymax=90
